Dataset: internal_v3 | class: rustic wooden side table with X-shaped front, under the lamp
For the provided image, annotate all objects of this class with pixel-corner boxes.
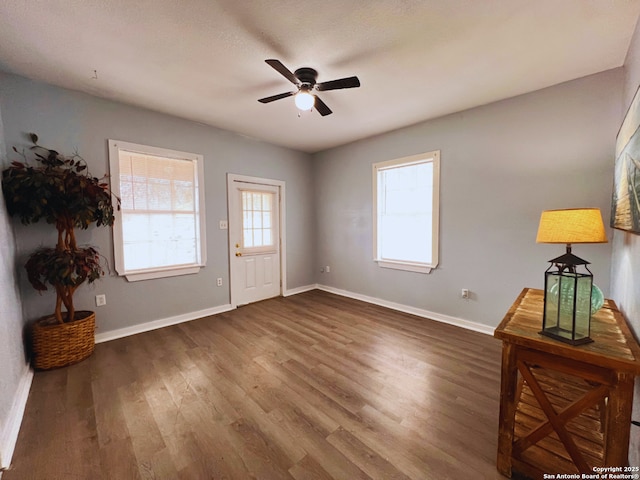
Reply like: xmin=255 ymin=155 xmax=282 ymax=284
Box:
xmin=494 ymin=288 xmax=640 ymax=478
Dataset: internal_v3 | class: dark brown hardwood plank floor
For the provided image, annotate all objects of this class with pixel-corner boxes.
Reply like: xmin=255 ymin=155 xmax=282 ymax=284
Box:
xmin=3 ymin=290 xmax=504 ymax=480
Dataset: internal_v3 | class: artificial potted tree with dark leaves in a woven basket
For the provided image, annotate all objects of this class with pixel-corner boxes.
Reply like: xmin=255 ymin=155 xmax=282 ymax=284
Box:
xmin=2 ymin=133 xmax=119 ymax=370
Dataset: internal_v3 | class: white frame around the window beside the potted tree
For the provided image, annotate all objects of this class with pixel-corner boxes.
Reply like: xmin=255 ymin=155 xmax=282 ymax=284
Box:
xmin=109 ymin=139 xmax=207 ymax=282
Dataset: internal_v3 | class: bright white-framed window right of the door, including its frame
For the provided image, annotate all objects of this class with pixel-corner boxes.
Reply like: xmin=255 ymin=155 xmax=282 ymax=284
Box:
xmin=373 ymin=151 xmax=440 ymax=273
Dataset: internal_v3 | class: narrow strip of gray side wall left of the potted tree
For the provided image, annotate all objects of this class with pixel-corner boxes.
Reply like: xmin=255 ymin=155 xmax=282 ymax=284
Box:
xmin=0 ymin=92 xmax=27 ymax=462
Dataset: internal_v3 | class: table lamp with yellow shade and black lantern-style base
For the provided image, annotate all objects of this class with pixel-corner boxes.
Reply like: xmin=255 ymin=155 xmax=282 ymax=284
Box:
xmin=536 ymin=208 xmax=607 ymax=345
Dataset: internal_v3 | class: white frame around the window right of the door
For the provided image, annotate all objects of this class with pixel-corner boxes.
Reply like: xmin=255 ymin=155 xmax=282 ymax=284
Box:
xmin=372 ymin=150 xmax=440 ymax=273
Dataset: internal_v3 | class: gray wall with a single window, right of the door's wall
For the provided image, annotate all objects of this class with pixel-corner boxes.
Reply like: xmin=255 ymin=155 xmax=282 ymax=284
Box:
xmin=314 ymin=69 xmax=623 ymax=326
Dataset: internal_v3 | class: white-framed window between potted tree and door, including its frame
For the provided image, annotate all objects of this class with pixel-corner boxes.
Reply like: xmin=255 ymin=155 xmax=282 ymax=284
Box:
xmin=109 ymin=140 xmax=206 ymax=281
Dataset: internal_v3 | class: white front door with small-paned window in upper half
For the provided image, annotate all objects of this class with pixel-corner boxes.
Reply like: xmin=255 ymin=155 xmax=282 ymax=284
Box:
xmin=227 ymin=174 xmax=282 ymax=306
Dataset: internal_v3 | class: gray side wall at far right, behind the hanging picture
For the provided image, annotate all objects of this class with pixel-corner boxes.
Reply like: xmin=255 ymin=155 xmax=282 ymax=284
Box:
xmin=611 ymin=15 xmax=640 ymax=465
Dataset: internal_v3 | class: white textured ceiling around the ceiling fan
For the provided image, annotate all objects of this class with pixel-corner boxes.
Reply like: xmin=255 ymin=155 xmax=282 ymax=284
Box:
xmin=0 ymin=0 xmax=640 ymax=152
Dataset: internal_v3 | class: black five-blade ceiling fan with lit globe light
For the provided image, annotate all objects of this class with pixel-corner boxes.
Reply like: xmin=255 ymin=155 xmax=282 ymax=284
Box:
xmin=258 ymin=59 xmax=360 ymax=117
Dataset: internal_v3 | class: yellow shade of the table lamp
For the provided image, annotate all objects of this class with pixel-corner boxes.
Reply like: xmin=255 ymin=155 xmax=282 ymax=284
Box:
xmin=536 ymin=208 xmax=608 ymax=244
